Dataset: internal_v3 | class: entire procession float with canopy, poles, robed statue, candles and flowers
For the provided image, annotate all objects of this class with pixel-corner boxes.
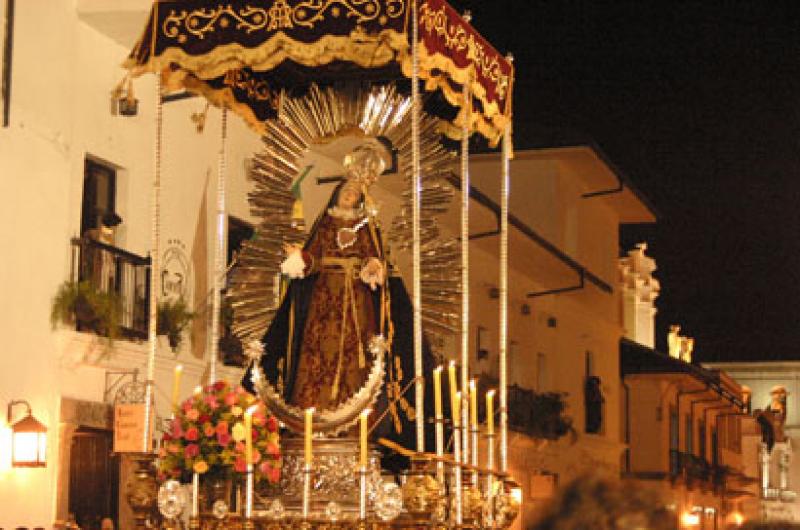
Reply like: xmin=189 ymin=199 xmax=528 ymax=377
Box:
xmin=119 ymin=0 xmax=520 ymax=529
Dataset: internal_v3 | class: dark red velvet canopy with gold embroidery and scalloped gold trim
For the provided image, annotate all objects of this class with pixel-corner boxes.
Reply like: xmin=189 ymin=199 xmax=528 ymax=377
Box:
xmin=125 ymin=0 xmax=514 ymax=144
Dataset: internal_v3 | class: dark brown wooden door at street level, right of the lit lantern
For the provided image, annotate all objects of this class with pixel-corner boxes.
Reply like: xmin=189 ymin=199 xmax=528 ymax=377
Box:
xmin=69 ymin=428 xmax=119 ymax=530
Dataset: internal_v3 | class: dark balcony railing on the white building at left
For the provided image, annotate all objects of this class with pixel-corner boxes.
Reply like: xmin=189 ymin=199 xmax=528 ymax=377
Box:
xmin=71 ymin=238 xmax=150 ymax=339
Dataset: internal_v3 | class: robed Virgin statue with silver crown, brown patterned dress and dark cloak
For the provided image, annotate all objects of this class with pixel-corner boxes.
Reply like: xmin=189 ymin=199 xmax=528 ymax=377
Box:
xmin=245 ymin=144 xmax=406 ymax=411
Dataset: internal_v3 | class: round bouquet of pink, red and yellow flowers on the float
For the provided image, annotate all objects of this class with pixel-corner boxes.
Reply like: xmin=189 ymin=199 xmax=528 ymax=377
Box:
xmin=159 ymin=381 xmax=281 ymax=484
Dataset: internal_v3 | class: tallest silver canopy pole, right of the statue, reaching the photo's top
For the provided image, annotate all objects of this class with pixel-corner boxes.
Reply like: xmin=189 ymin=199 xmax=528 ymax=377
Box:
xmin=411 ymin=0 xmax=425 ymax=452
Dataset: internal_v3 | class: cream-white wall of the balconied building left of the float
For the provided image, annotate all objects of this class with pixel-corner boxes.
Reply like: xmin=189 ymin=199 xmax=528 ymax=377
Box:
xmin=0 ymin=0 xmax=259 ymax=528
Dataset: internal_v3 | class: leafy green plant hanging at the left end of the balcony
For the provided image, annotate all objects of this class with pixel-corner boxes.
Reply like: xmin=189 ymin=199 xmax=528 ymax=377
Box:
xmin=50 ymin=281 xmax=122 ymax=341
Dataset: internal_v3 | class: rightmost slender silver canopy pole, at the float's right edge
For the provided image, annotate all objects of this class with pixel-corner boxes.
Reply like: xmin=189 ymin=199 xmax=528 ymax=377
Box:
xmin=500 ymin=119 xmax=511 ymax=473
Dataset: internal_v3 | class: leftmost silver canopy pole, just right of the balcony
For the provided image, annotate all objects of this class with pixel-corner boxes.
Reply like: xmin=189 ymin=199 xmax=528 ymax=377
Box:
xmin=142 ymin=75 xmax=164 ymax=453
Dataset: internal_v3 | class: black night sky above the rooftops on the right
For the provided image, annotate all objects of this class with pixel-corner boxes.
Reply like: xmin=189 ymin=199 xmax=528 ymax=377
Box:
xmin=452 ymin=0 xmax=800 ymax=361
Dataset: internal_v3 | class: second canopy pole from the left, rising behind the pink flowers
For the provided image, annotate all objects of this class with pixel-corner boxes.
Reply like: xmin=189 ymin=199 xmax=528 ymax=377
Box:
xmin=208 ymin=107 xmax=228 ymax=384
